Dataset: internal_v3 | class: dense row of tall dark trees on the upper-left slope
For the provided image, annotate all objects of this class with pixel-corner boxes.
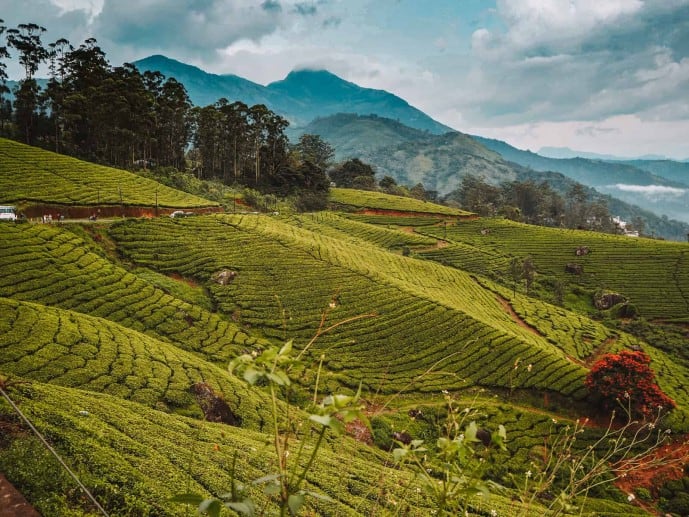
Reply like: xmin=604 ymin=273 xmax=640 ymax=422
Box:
xmin=0 ymin=20 xmax=334 ymax=204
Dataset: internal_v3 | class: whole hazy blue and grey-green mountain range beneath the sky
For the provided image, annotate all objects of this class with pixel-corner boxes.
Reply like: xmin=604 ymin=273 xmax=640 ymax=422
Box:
xmin=8 ymin=55 xmax=689 ymax=238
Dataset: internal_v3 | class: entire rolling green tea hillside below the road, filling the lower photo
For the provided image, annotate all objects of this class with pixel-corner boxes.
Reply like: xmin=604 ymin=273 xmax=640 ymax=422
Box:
xmin=0 ymin=143 xmax=689 ymax=516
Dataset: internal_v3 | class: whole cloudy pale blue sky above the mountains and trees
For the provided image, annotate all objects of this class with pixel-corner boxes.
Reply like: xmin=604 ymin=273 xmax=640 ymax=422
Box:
xmin=0 ymin=0 xmax=689 ymax=159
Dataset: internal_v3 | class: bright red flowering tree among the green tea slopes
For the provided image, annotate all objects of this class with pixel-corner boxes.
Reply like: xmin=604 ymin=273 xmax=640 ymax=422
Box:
xmin=585 ymin=350 xmax=675 ymax=419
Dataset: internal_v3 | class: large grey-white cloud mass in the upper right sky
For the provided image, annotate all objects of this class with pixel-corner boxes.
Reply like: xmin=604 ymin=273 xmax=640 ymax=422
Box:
xmin=448 ymin=0 xmax=689 ymax=125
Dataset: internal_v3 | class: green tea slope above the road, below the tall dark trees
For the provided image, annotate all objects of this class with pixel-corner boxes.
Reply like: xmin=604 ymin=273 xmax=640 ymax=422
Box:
xmin=0 ymin=138 xmax=217 ymax=208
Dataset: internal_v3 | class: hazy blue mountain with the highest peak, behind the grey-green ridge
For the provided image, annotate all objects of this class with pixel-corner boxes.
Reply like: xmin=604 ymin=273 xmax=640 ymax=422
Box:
xmin=134 ymin=55 xmax=453 ymax=134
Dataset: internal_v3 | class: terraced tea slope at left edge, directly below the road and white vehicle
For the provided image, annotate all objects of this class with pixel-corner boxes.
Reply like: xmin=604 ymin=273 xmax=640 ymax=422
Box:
xmin=0 ymin=224 xmax=256 ymax=362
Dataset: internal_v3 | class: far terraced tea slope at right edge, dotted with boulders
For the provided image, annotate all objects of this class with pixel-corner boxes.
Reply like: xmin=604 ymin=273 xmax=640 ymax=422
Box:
xmin=408 ymin=219 xmax=689 ymax=319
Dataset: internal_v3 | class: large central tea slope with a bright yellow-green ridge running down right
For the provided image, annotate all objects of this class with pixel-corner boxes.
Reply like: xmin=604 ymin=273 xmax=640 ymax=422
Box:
xmin=111 ymin=212 xmax=600 ymax=397
